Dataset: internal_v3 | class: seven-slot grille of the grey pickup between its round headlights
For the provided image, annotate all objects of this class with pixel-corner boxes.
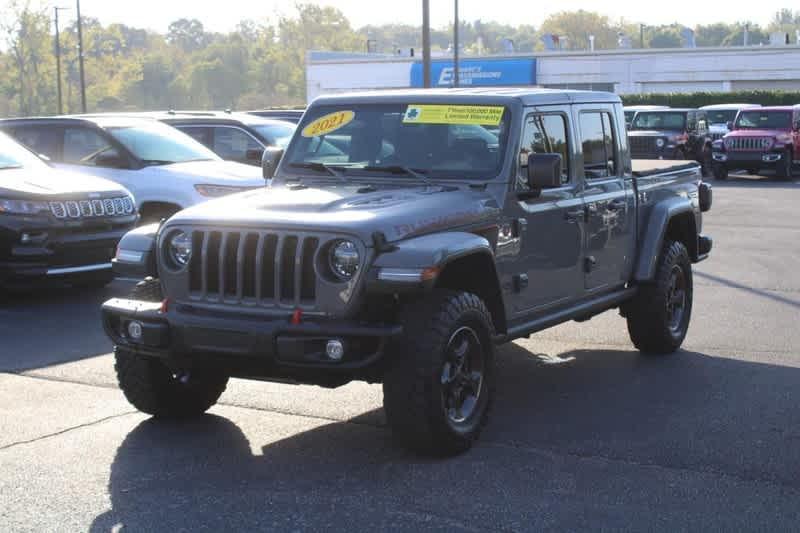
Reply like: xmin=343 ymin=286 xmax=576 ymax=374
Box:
xmin=189 ymin=231 xmax=320 ymax=307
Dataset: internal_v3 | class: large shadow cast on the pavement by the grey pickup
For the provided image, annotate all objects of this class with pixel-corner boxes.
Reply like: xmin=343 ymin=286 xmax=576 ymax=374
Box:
xmin=87 ymin=344 xmax=800 ymax=531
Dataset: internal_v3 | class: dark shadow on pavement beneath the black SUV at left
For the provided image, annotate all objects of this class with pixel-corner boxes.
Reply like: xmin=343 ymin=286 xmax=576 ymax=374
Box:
xmin=0 ymin=281 xmax=132 ymax=372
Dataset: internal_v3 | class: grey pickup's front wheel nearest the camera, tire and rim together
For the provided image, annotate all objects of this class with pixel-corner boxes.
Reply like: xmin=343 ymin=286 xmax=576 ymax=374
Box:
xmin=383 ymin=290 xmax=495 ymax=456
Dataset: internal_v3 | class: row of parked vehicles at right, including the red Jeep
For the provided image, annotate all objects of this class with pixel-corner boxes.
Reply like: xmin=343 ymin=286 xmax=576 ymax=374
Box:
xmin=625 ymin=104 xmax=800 ymax=180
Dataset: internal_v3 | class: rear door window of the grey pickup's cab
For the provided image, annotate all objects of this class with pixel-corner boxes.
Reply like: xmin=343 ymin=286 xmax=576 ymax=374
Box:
xmin=580 ymin=111 xmax=617 ymax=179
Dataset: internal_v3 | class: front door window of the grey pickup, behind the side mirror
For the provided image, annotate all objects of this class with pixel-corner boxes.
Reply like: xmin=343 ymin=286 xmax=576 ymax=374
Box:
xmin=517 ymin=114 xmax=569 ymax=191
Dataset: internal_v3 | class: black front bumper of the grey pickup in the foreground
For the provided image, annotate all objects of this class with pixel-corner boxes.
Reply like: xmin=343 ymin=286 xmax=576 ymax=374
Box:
xmin=102 ymin=298 xmax=402 ymax=371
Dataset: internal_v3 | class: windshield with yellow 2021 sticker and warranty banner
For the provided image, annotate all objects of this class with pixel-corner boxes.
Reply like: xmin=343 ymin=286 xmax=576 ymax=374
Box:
xmin=281 ymin=104 xmax=510 ymax=179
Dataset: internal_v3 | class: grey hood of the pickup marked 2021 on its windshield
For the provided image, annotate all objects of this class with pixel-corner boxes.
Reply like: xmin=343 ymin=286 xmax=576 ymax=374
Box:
xmin=169 ymin=184 xmax=500 ymax=244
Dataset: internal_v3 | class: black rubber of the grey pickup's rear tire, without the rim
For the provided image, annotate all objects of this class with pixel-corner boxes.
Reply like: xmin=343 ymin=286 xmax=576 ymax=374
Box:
xmin=625 ymin=241 xmax=694 ymax=355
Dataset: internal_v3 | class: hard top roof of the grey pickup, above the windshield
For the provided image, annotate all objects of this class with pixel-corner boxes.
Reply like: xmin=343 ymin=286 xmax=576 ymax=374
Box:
xmin=312 ymin=87 xmax=620 ymax=106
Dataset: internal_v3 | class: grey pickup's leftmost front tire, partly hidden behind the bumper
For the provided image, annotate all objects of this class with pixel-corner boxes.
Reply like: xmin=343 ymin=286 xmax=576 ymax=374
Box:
xmin=114 ymin=278 xmax=228 ymax=418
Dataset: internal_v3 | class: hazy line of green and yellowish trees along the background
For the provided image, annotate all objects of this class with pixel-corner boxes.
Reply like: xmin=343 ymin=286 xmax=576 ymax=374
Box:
xmin=0 ymin=0 xmax=800 ymax=116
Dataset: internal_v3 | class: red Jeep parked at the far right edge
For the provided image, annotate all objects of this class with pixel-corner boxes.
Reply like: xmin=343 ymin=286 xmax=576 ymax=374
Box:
xmin=712 ymin=105 xmax=800 ymax=180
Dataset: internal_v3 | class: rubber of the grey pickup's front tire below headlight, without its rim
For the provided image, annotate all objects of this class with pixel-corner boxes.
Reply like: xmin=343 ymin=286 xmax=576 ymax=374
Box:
xmin=383 ymin=290 xmax=495 ymax=456
